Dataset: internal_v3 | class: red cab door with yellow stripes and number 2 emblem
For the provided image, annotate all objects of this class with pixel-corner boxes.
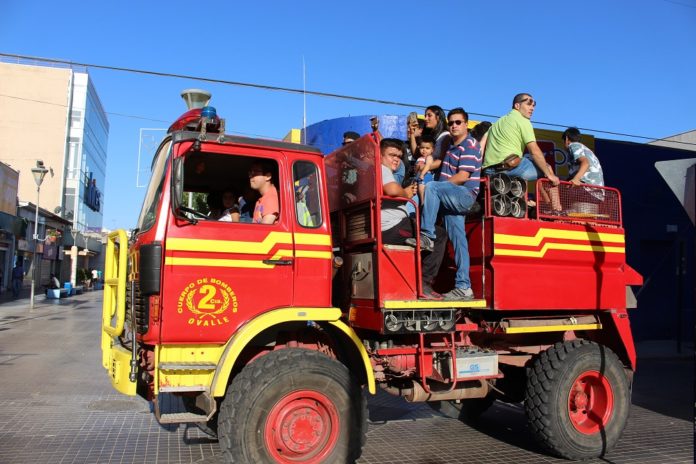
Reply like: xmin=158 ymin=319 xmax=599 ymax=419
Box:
xmin=161 ymin=149 xmax=294 ymax=343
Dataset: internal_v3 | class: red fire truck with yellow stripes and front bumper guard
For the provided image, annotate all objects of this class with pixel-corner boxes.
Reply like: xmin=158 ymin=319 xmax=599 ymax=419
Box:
xmin=102 ymin=91 xmax=642 ymax=463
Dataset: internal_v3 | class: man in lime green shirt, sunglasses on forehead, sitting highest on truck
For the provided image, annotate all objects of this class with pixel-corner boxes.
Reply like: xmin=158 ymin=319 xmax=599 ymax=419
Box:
xmin=483 ymin=93 xmax=559 ymax=185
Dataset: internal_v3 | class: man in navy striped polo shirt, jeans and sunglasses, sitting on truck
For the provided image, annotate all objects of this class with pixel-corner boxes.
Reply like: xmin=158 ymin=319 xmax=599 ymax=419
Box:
xmin=410 ymin=108 xmax=481 ymax=300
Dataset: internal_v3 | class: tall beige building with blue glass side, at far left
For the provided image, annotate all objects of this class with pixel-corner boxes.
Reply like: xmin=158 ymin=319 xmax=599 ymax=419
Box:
xmin=0 ymin=59 xmax=109 ymax=290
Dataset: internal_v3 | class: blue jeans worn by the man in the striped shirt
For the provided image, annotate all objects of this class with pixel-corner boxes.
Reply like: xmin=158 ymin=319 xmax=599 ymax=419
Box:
xmin=421 ymin=181 xmax=476 ymax=288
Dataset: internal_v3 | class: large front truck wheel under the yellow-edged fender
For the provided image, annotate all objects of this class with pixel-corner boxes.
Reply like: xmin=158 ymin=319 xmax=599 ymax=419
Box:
xmin=218 ymin=348 xmax=367 ymax=464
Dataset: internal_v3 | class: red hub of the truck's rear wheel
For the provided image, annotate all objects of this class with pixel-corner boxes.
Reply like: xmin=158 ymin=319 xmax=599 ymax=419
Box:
xmin=568 ymin=371 xmax=614 ymax=435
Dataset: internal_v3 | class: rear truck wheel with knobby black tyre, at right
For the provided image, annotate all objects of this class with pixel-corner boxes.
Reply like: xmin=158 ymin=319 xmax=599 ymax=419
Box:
xmin=524 ymin=340 xmax=630 ymax=459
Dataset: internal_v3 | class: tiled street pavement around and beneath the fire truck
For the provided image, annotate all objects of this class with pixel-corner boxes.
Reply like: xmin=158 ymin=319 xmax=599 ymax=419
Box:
xmin=0 ymin=292 xmax=694 ymax=464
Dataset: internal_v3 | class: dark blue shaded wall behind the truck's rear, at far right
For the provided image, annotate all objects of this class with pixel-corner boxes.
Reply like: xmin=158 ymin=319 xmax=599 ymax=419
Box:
xmin=595 ymin=139 xmax=696 ymax=341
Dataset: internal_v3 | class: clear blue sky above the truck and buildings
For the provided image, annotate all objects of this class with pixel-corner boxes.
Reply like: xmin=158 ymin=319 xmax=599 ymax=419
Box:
xmin=0 ymin=0 xmax=696 ymax=229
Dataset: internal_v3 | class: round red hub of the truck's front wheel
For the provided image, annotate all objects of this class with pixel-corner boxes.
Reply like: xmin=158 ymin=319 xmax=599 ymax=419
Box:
xmin=264 ymin=390 xmax=340 ymax=463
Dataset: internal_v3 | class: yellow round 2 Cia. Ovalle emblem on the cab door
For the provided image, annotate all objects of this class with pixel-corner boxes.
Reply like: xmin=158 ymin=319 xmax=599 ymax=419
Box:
xmin=177 ymin=278 xmax=237 ymax=327
